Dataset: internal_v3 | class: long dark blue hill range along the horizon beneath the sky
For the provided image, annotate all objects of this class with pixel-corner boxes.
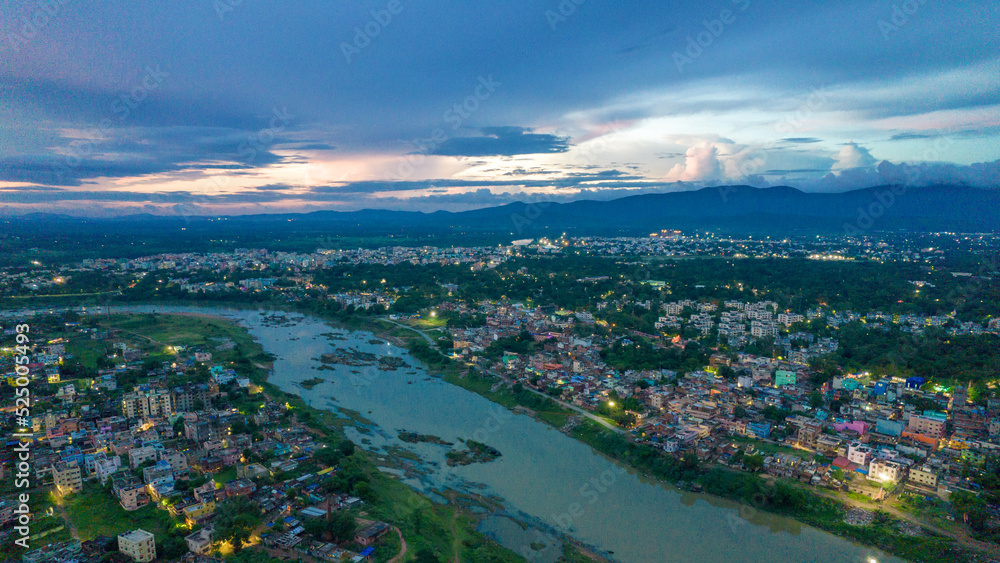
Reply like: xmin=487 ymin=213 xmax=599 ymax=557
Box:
xmin=11 ymin=185 xmax=1000 ymax=235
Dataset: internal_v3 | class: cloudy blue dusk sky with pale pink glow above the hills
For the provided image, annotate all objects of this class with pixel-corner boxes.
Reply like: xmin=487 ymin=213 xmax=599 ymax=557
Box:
xmin=0 ymin=0 xmax=1000 ymax=216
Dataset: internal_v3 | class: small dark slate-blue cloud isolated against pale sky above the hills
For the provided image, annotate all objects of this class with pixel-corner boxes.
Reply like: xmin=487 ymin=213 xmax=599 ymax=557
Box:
xmin=428 ymin=127 xmax=569 ymax=156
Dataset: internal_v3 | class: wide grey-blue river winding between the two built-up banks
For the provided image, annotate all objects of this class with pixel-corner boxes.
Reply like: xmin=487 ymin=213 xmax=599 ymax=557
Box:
xmin=84 ymin=305 xmax=901 ymax=563
